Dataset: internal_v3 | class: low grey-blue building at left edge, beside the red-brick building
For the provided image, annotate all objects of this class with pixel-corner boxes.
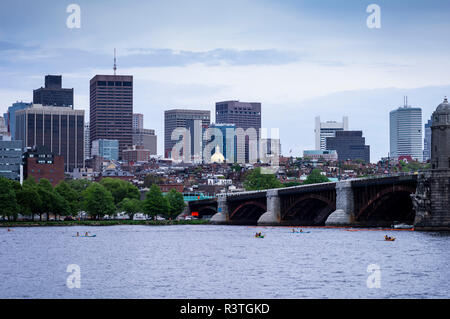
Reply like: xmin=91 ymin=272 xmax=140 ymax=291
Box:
xmin=0 ymin=141 xmax=23 ymax=181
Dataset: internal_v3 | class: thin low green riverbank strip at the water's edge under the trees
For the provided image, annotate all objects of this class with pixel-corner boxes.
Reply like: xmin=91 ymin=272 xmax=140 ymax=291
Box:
xmin=0 ymin=219 xmax=209 ymax=227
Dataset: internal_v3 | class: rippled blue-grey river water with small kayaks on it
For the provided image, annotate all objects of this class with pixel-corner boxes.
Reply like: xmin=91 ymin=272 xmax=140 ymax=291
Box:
xmin=0 ymin=225 xmax=450 ymax=299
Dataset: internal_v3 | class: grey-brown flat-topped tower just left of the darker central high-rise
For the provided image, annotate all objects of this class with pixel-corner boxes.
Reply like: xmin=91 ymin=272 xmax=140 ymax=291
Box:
xmin=164 ymin=109 xmax=211 ymax=158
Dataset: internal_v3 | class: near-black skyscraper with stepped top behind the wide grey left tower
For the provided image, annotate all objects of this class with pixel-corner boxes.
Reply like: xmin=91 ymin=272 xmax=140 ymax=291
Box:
xmin=33 ymin=75 xmax=73 ymax=108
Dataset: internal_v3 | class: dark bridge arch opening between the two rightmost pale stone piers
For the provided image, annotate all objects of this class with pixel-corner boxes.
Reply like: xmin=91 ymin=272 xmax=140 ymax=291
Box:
xmin=282 ymin=193 xmax=336 ymax=226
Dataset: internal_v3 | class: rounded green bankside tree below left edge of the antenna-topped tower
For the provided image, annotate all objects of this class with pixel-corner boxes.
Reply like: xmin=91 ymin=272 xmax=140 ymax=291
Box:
xmin=83 ymin=183 xmax=116 ymax=219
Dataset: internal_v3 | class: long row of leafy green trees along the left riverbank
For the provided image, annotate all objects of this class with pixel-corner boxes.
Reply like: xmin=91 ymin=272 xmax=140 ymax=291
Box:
xmin=0 ymin=177 xmax=186 ymax=220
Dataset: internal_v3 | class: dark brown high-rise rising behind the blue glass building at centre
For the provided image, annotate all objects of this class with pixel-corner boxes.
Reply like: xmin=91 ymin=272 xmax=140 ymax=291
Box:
xmin=216 ymin=101 xmax=261 ymax=163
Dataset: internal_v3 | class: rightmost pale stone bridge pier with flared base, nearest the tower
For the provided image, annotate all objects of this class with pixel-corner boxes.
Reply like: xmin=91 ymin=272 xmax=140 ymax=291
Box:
xmin=325 ymin=181 xmax=354 ymax=226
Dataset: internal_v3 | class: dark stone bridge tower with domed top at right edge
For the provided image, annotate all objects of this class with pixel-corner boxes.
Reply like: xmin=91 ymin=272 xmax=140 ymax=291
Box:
xmin=411 ymin=98 xmax=450 ymax=230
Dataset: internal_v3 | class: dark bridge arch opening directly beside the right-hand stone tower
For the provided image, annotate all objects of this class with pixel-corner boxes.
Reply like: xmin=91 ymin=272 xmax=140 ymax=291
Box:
xmin=356 ymin=185 xmax=416 ymax=226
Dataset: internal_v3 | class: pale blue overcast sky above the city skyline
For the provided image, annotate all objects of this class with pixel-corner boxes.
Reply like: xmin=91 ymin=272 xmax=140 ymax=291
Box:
xmin=0 ymin=0 xmax=450 ymax=162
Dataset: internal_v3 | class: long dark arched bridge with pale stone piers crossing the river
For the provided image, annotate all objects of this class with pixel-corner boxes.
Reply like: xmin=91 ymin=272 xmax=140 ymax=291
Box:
xmin=189 ymin=174 xmax=417 ymax=226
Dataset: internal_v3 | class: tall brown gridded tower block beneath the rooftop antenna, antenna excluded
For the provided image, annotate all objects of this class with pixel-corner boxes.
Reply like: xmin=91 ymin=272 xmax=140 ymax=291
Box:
xmin=89 ymin=75 xmax=133 ymax=157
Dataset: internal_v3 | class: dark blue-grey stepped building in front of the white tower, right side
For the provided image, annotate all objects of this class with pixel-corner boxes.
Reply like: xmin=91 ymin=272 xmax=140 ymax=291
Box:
xmin=326 ymin=131 xmax=370 ymax=163
